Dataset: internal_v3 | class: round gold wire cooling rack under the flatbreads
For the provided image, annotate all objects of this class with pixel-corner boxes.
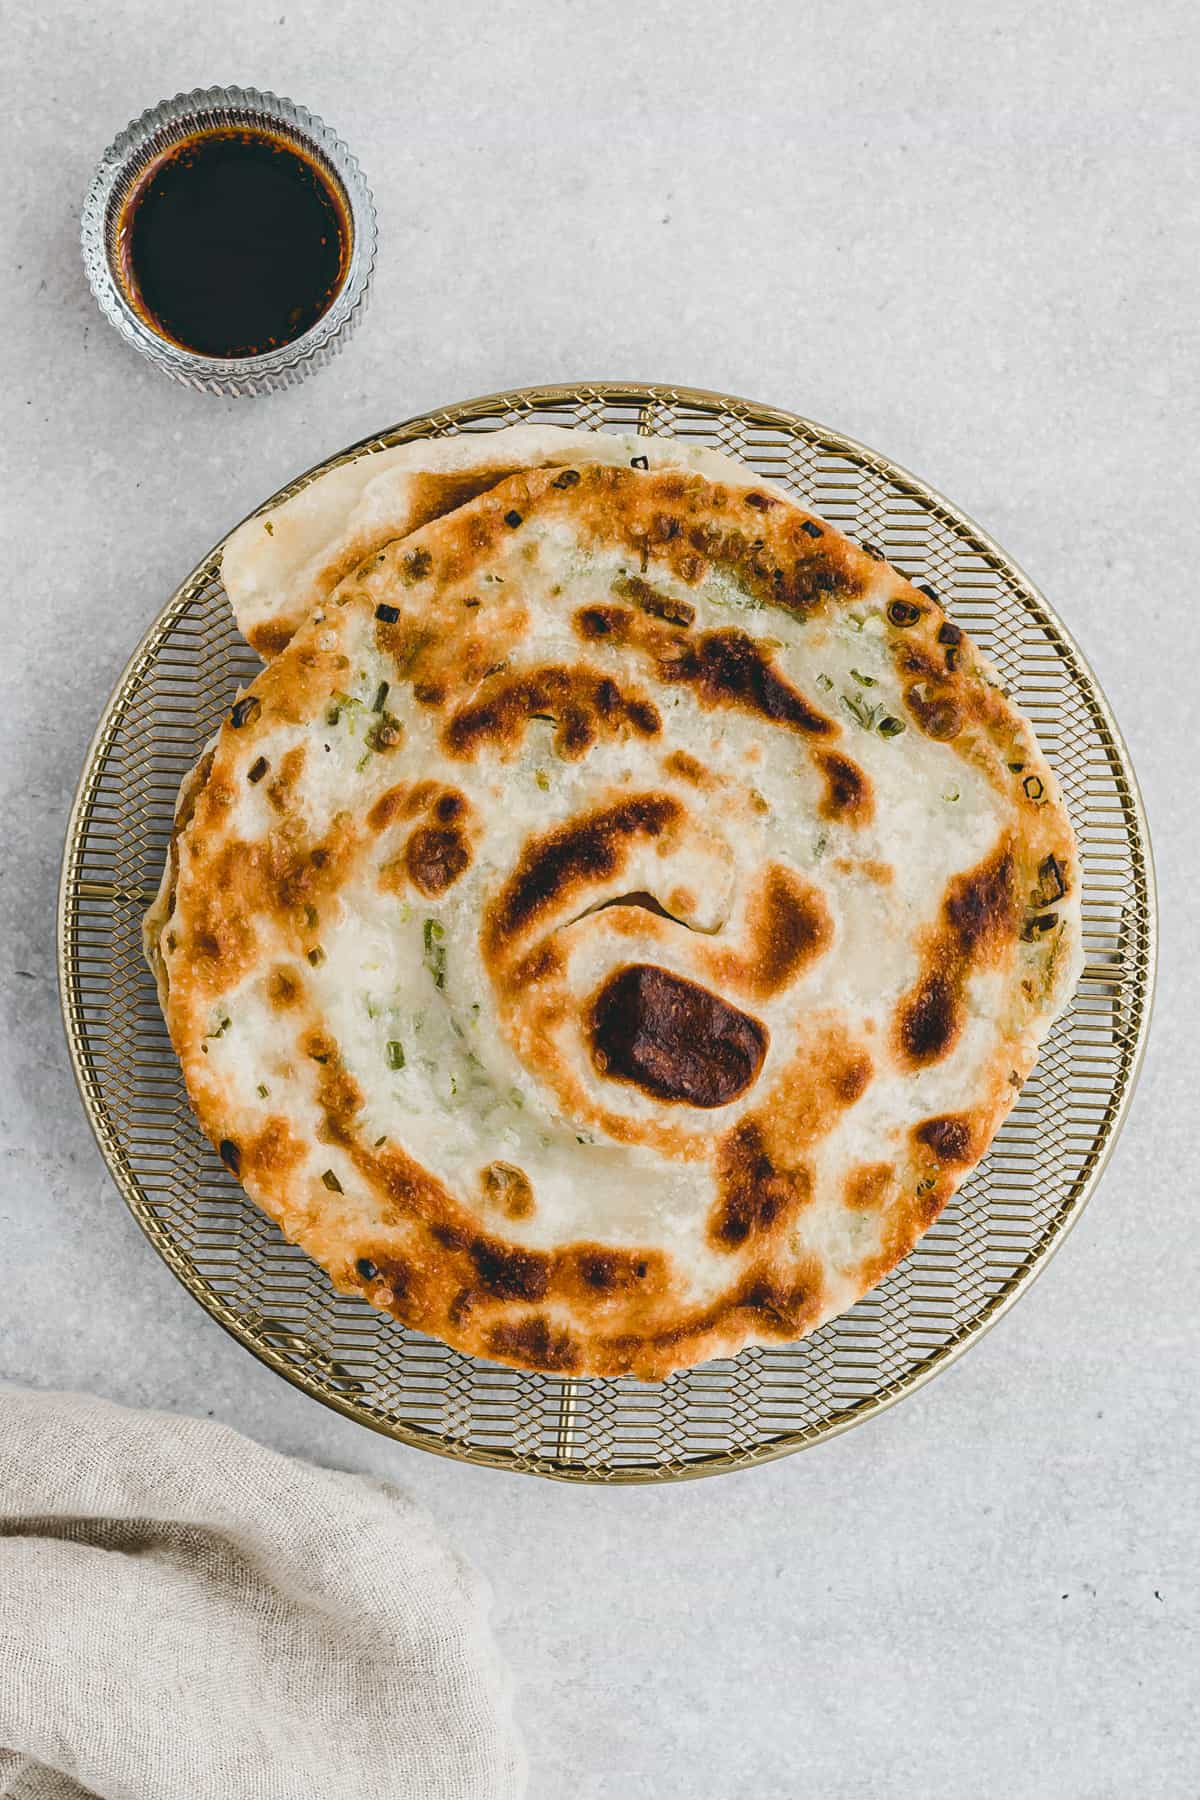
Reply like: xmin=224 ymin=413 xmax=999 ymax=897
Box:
xmin=58 ymin=382 xmax=1155 ymax=1483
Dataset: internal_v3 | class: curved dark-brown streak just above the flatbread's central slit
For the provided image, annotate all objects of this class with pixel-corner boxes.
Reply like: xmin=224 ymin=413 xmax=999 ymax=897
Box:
xmin=484 ymin=794 xmax=682 ymax=958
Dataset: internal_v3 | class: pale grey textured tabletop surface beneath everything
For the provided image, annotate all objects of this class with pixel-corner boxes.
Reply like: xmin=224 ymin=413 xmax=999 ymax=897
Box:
xmin=0 ymin=0 xmax=1200 ymax=1800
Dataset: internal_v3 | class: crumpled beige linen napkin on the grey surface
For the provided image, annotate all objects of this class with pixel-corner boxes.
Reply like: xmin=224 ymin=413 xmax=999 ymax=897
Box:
xmin=0 ymin=1388 xmax=525 ymax=1800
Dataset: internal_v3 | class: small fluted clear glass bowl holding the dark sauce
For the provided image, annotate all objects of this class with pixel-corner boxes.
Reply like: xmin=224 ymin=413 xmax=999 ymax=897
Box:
xmin=81 ymin=88 xmax=376 ymax=394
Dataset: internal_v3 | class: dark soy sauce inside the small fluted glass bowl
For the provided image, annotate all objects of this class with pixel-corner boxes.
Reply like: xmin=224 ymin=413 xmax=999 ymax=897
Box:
xmin=119 ymin=128 xmax=351 ymax=356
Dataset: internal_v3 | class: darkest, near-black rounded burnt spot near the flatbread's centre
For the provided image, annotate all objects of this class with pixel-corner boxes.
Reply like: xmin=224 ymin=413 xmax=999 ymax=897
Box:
xmin=588 ymin=963 xmax=766 ymax=1107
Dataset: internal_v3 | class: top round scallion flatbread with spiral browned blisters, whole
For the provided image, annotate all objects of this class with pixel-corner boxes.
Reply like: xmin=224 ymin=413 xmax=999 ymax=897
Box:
xmin=148 ymin=450 xmax=1079 ymax=1377
